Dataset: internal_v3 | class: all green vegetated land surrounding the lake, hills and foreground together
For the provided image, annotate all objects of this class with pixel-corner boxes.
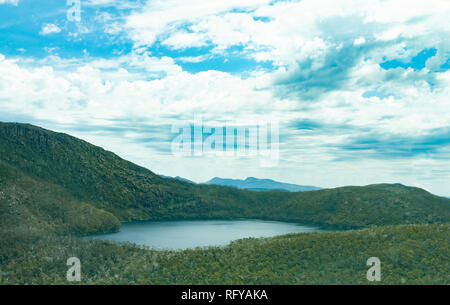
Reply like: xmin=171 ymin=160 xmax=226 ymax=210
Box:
xmin=0 ymin=123 xmax=450 ymax=284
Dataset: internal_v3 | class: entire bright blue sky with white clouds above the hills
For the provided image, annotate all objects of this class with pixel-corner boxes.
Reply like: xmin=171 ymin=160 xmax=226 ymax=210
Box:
xmin=0 ymin=0 xmax=450 ymax=196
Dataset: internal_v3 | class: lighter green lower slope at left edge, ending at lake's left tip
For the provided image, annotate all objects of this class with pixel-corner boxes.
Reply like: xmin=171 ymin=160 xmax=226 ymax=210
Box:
xmin=0 ymin=161 xmax=120 ymax=236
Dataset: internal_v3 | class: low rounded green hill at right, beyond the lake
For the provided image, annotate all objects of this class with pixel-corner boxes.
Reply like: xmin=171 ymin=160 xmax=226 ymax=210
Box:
xmin=274 ymin=184 xmax=450 ymax=228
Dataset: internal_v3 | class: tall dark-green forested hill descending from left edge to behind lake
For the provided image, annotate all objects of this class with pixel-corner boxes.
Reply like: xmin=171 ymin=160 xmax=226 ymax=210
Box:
xmin=0 ymin=123 xmax=289 ymax=227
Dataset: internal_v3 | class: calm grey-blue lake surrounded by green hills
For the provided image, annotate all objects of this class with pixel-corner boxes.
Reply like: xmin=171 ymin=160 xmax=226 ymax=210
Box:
xmin=90 ymin=220 xmax=323 ymax=249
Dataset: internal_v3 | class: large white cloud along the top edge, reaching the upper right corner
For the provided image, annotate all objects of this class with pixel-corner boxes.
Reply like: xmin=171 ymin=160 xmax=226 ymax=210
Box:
xmin=121 ymin=0 xmax=450 ymax=74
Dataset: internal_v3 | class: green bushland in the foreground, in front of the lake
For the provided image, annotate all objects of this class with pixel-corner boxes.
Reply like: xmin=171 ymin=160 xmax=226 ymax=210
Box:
xmin=0 ymin=225 xmax=450 ymax=284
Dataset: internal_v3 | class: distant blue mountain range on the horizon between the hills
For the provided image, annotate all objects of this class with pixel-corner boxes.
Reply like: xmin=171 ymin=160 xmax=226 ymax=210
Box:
xmin=205 ymin=177 xmax=321 ymax=192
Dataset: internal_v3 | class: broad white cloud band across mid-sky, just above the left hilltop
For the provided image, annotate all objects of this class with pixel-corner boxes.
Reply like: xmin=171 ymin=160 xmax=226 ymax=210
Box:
xmin=0 ymin=52 xmax=450 ymax=147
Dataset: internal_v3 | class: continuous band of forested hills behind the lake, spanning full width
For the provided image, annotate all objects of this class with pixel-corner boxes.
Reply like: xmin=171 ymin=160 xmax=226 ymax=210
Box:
xmin=0 ymin=123 xmax=450 ymax=232
